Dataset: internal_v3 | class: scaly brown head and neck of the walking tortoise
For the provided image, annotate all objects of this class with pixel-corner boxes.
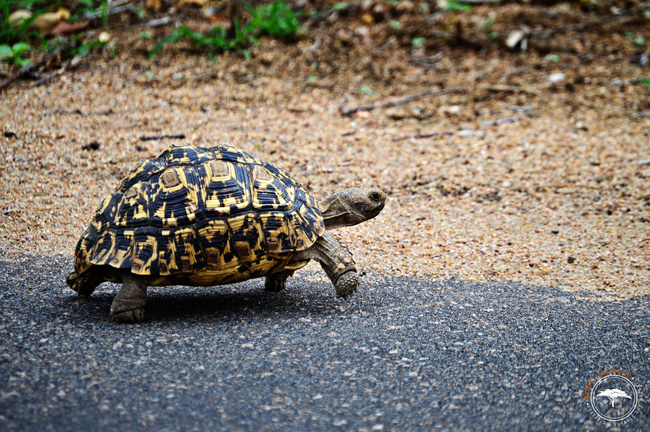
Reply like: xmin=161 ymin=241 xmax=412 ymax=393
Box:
xmin=321 ymin=188 xmax=386 ymax=230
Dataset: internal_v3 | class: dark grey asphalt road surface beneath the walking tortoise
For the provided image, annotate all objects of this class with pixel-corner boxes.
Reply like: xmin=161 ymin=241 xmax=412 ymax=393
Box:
xmin=0 ymin=256 xmax=650 ymax=431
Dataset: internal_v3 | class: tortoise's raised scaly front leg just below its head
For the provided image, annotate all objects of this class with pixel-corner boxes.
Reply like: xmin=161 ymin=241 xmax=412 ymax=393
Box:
xmin=294 ymin=231 xmax=359 ymax=297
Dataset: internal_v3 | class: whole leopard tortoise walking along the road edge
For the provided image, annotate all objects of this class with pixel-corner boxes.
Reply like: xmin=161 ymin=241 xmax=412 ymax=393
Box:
xmin=66 ymin=145 xmax=386 ymax=323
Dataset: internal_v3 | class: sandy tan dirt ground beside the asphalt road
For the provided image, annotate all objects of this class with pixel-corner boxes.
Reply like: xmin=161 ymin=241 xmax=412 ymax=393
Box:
xmin=0 ymin=4 xmax=650 ymax=299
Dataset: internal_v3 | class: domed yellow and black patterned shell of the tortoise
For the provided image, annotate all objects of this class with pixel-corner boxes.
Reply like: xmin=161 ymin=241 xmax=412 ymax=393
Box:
xmin=75 ymin=145 xmax=325 ymax=276
